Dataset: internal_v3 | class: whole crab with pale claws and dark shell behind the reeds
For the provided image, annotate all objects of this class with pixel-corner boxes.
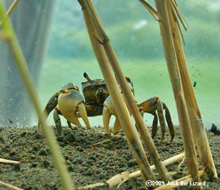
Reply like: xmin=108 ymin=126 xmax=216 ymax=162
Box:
xmin=38 ymin=73 xmax=175 ymax=143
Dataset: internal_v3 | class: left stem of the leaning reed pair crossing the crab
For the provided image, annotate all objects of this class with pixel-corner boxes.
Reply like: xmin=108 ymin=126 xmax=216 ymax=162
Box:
xmin=79 ymin=0 xmax=155 ymax=188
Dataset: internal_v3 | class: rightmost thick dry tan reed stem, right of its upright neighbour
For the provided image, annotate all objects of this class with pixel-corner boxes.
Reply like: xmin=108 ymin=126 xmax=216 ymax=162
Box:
xmin=168 ymin=0 xmax=217 ymax=180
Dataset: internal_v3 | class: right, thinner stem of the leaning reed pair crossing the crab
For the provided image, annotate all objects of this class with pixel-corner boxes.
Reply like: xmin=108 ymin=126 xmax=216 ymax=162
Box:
xmin=80 ymin=1 xmax=171 ymax=182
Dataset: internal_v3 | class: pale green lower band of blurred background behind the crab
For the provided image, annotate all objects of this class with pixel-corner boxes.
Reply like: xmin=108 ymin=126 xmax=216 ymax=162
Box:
xmin=39 ymin=58 xmax=220 ymax=128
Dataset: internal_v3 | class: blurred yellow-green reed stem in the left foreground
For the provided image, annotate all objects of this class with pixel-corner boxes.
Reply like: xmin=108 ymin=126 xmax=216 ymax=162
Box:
xmin=0 ymin=0 xmax=74 ymax=190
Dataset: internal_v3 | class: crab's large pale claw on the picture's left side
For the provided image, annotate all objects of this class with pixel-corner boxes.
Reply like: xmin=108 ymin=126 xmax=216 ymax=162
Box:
xmin=58 ymin=89 xmax=91 ymax=129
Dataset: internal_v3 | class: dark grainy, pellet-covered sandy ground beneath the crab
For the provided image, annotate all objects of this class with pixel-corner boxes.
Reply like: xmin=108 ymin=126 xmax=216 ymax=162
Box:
xmin=0 ymin=124 xmax=220 ymax=190
